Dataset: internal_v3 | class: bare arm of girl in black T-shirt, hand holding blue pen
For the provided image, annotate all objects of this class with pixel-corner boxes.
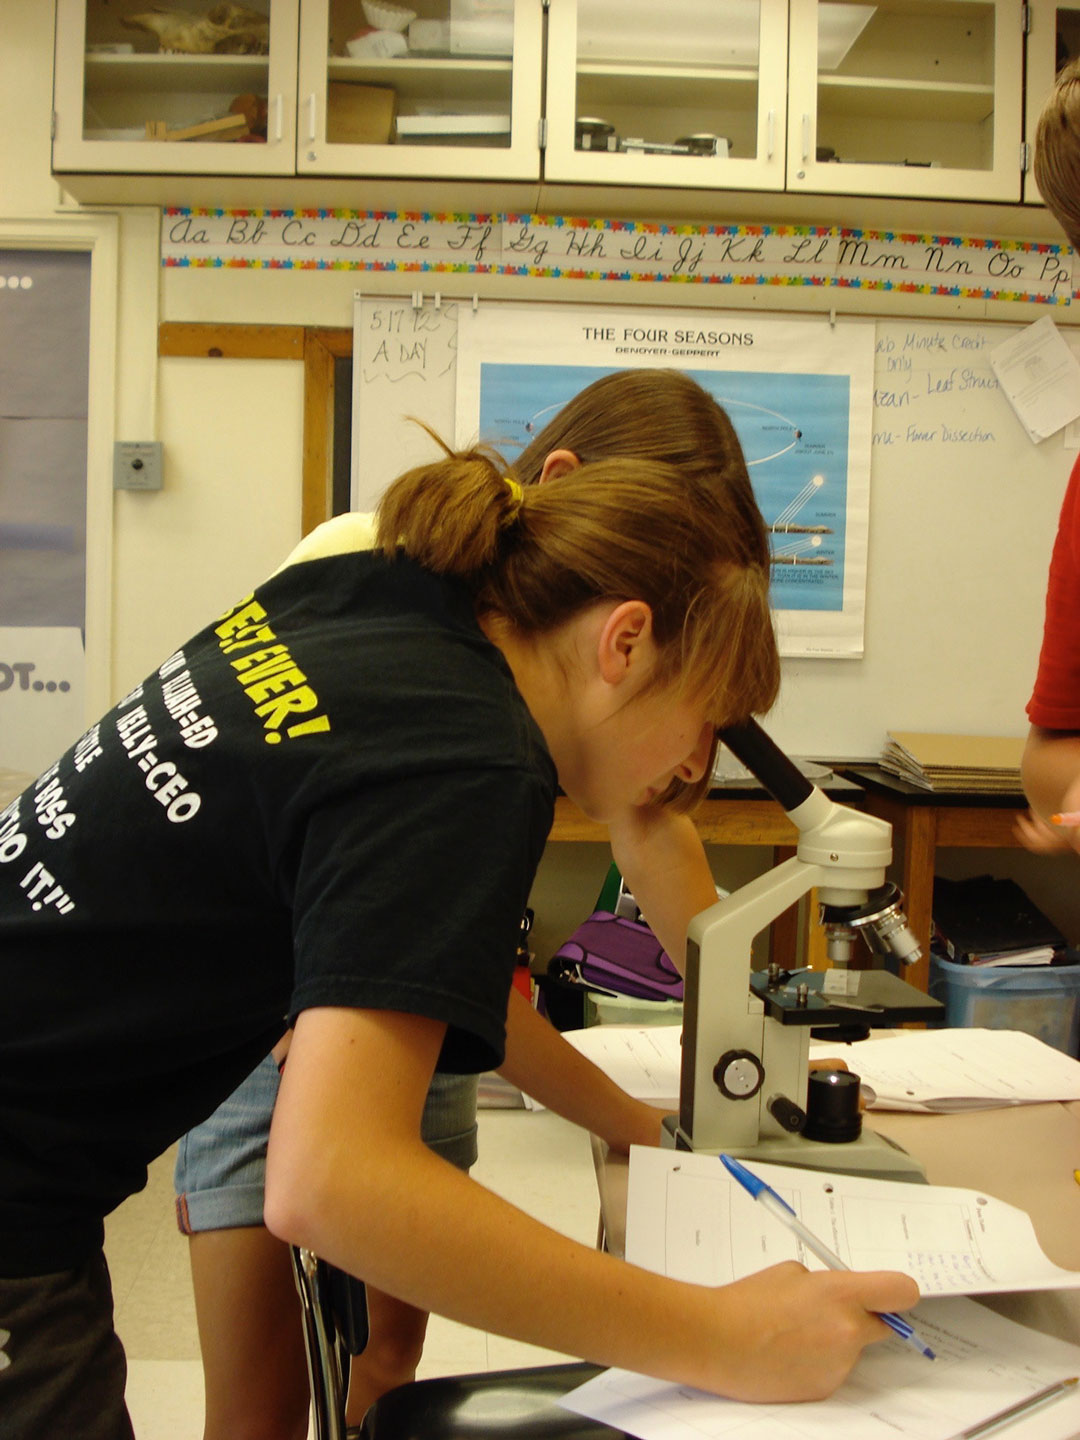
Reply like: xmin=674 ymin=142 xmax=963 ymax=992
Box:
xmin=265 ymin=1009 xmax=917 ymax=1400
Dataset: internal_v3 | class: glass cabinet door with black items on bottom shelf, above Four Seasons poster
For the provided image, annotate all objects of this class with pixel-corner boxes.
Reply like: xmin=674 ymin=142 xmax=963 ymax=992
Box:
xmin=544 ymin=0 xmax=788 ymax=190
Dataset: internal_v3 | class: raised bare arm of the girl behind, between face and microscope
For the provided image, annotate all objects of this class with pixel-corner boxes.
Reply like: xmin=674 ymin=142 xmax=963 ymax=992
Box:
xmin=608 ymin=805 xmax=716 ymax=972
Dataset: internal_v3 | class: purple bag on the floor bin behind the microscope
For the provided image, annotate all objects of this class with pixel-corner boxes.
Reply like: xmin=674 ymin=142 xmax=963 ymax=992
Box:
xmin=547 ymin=910 xmax=683 ymax=999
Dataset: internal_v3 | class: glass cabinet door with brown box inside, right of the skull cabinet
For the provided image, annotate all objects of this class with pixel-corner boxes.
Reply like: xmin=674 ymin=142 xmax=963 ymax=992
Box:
xmin=297 ymin=0 xmax=543 ymax=180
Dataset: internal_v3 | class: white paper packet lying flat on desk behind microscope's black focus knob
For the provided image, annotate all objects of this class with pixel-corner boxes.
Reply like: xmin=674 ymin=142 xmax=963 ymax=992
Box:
xmin=811 ymin=1028 xmax=1080 ymax=1113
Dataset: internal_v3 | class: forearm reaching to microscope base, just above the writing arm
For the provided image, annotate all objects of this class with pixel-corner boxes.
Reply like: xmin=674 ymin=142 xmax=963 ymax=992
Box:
xmin=498 ymin=991 xmax=664 ymax=1152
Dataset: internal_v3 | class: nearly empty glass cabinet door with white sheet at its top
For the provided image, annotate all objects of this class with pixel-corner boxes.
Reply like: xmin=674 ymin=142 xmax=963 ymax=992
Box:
xmin=788 ymin=0 xmax=1024 ymax=203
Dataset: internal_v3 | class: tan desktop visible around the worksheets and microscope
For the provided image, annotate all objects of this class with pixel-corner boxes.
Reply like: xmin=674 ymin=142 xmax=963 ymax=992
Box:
xmin=592 ymin=1102 xmax=1080 ymax=1345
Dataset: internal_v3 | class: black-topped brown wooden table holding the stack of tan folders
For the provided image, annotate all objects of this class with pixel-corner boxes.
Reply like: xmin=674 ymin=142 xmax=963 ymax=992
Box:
xmin=844 ymin=765 xmax=1028 ymax=991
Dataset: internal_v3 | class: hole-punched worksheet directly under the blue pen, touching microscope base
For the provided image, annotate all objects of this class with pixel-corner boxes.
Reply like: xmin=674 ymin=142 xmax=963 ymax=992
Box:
xmin=626 ymin=1145 xmax=1080 ymax=1296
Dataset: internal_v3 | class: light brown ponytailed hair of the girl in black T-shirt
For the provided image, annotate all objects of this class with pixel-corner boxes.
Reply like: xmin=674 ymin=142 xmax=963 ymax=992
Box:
xmin=377 ymin=426 xmax=779 ymax=808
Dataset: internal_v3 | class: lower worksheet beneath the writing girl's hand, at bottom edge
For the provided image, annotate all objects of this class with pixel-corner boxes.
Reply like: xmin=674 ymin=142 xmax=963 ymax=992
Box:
xmin=560 ymin=1297 xmax=1080 ymax=1440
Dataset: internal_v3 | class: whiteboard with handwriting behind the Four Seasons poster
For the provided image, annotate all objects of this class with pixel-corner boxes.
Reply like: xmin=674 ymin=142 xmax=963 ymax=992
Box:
xmin=353 ymin=295 xmax=1076 ymax=759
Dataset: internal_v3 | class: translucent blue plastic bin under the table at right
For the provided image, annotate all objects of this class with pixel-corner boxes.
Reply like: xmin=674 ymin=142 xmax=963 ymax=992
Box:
xmin=930 ymin=952 xmax=1080 ymax=1056
